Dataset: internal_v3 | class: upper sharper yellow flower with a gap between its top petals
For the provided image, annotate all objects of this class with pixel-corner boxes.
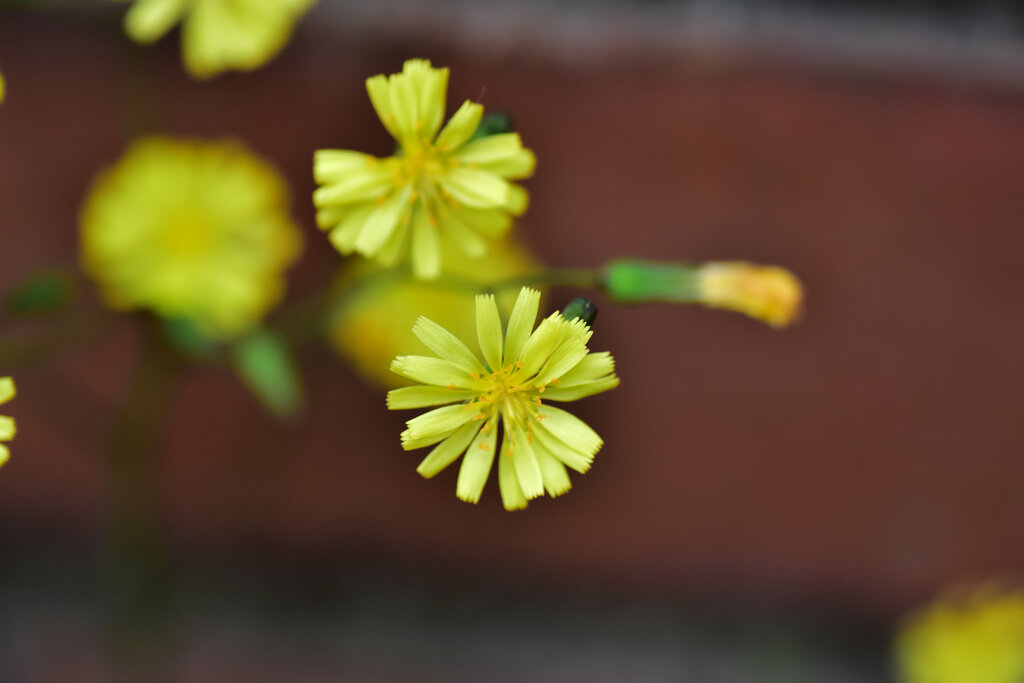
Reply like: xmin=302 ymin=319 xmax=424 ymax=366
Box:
xmin=313 ymin=59 xmax=536 ymax=279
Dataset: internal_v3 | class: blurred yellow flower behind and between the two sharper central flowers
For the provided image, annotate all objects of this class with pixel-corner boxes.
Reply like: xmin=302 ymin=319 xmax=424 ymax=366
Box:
xmin=329 ymin=238 xmax=539 ymax=389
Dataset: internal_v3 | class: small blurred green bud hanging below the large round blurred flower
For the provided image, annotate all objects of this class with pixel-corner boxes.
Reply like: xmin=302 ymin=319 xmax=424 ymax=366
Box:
xmin=231 ymin=330 xmax=302 ymax=418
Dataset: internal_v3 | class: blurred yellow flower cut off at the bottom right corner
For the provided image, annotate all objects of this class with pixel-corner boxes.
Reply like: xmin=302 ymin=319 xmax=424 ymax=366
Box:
xmin=896 ymin=588 xmax=1024 ymax=683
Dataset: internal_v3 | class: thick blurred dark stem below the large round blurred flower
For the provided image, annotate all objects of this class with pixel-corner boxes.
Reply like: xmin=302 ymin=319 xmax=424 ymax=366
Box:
xmin=103 ymin=326 xmax=178 ymax=683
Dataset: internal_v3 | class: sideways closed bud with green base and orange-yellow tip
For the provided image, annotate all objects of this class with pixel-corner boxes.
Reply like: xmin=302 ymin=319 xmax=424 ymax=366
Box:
xmin=602 ymin=259 xmax=803 ymax=328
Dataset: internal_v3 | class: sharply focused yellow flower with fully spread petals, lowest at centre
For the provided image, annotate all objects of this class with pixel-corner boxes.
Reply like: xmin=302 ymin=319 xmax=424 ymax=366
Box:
xmin=387 ymin=288 xmax=618 ymax=510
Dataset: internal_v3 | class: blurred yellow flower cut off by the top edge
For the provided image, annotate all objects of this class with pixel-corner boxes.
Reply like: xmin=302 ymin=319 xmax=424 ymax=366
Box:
xmin=119 ymin=0 xmax=315 ymax=78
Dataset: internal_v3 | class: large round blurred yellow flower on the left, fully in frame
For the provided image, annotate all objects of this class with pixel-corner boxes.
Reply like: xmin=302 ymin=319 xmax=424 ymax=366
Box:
xmin=82 ymin=137 xmax=300 ymax=338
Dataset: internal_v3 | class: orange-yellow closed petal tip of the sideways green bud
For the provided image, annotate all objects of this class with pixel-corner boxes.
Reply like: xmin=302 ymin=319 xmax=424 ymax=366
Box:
xmin=698 ymin=261 xmax=803 ymax=328
